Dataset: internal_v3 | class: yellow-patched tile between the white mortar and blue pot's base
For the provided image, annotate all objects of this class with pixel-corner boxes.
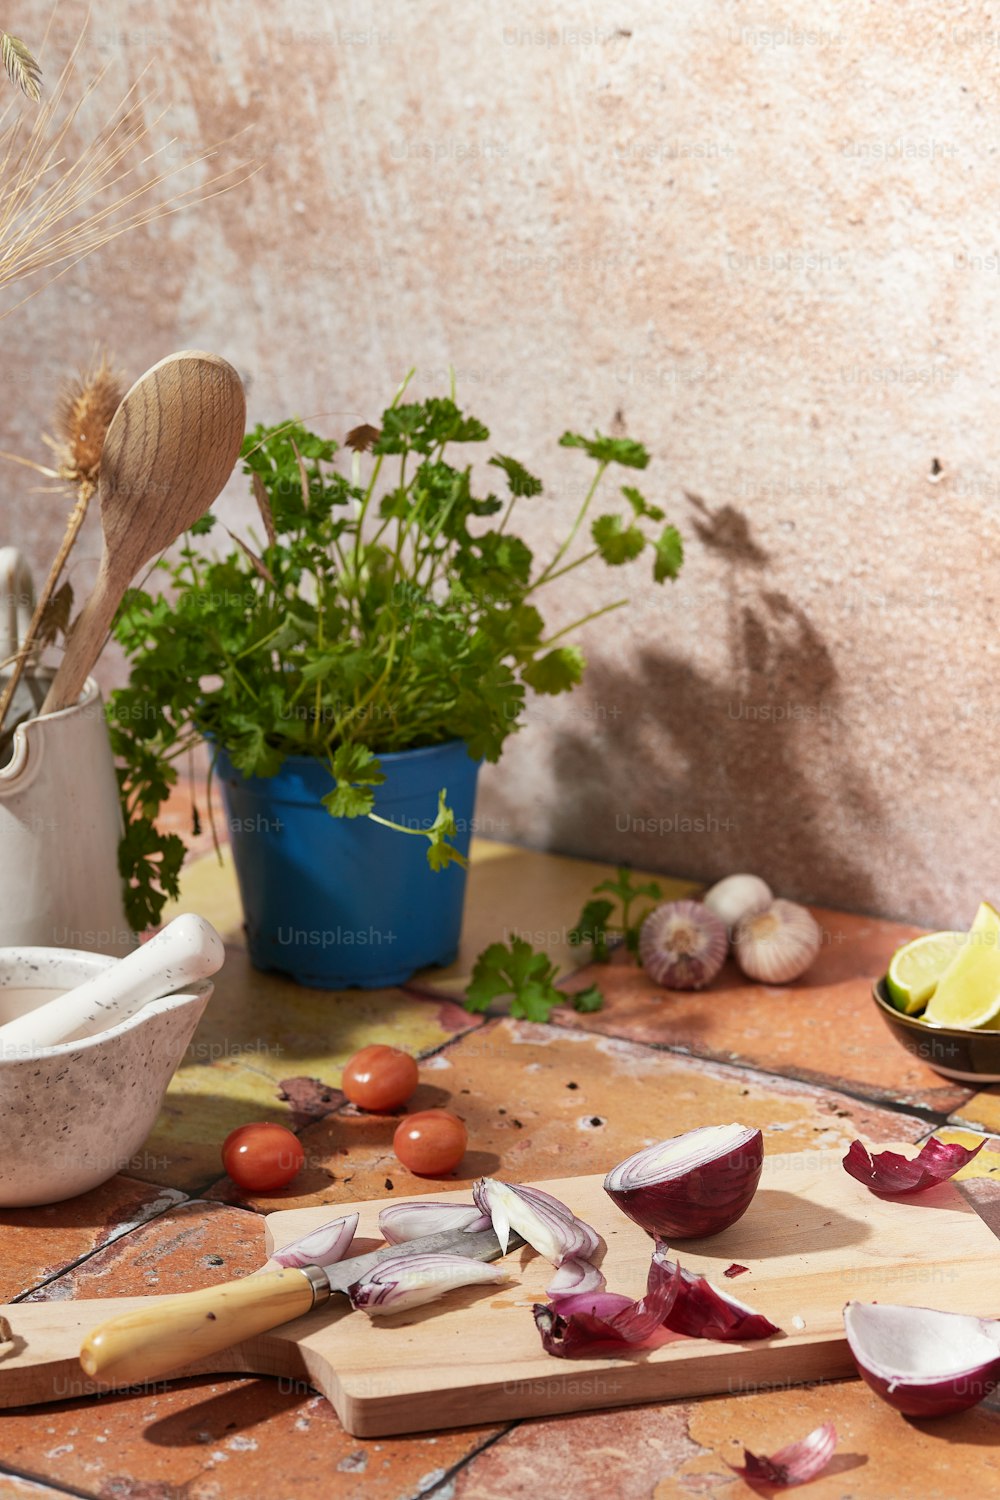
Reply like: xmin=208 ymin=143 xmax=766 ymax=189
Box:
xmin=128 ymin=947 xmax=481 ymax=1191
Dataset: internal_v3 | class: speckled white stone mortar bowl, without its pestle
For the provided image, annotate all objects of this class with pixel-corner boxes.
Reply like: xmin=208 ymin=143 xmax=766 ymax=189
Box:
xmin=0 ymin=948 xmax=213 ymax=1208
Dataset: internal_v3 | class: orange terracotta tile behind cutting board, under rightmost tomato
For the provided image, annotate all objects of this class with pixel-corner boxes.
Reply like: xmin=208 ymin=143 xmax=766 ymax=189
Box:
xmin=239 ymin=1020 xmax=927 ymax=1209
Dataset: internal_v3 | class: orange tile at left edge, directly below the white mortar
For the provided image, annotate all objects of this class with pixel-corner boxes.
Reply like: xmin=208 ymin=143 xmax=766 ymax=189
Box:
xmin=0 ymin=1176 xmax=181 ymax=1302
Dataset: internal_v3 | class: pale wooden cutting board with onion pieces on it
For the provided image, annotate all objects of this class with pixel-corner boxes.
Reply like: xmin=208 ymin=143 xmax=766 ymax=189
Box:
xmin=0 ymin=1145 xmax=1000 ymax=1437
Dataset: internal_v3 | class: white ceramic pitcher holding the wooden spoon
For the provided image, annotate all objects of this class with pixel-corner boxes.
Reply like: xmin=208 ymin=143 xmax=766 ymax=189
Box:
xmin=0 ymin=549 xmax=136 ymax=957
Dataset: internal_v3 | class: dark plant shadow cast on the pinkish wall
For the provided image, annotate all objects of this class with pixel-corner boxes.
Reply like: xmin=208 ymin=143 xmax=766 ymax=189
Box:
xmin=549 ymin=495 xmax=905 ymax=911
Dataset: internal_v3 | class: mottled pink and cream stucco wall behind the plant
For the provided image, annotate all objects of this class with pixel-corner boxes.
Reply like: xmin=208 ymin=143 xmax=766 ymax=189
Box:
xmin=0 ymin=0 xmax=1000 ymax=924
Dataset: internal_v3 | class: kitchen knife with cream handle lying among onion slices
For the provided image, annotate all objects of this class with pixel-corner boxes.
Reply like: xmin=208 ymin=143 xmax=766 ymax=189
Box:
xmin=79 ymin=1229 xmax=525 ymax=1386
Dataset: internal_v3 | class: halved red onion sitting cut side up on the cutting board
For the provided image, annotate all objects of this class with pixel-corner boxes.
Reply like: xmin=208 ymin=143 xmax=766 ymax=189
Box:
xmin=604 ymin=1125 xmax=765 ymax=1239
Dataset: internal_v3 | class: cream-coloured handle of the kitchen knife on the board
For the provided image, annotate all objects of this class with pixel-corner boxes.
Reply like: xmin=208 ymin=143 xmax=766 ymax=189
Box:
xmin=79 ymin=1266 xmax=330 ymax=1386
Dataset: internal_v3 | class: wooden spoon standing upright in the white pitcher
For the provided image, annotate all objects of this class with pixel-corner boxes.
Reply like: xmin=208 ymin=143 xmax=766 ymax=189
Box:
xmin=42 ymin=351 xmax=246 ymax=714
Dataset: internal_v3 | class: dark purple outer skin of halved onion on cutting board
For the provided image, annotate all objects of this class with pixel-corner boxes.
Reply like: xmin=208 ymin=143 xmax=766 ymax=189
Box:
xmin=604 ymin=1131 xmax=765 ymax=1241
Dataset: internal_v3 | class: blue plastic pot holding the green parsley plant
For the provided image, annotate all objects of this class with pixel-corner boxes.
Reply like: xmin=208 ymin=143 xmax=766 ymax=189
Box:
xmin=216 ymin=740 xmax=480 ymax=990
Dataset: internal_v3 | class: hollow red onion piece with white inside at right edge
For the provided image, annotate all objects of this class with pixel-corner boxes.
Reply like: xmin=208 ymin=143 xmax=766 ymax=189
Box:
xmin=844 ymin=1302 xmax=1000 ymax=1416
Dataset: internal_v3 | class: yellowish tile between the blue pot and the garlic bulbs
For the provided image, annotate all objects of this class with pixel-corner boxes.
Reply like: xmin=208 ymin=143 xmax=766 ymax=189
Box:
xmin=409 ymin=839 xmax=700 ymax=995
